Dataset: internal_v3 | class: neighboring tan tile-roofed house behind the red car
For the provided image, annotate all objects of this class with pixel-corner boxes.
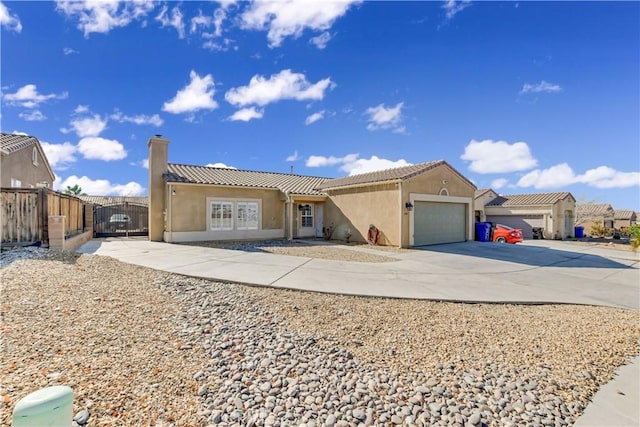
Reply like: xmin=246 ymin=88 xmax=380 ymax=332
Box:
xmin=476 ymin=192 xmax=576 ymax=239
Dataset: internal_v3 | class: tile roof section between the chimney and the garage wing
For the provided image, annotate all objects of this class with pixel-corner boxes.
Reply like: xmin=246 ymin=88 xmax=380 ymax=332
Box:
xmin=163 ymin=163 xmax=328 ymax=196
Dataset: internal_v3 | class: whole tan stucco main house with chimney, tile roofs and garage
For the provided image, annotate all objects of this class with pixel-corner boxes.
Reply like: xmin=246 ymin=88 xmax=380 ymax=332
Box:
xmin=149 ymin=136 xmax=476 ymax=247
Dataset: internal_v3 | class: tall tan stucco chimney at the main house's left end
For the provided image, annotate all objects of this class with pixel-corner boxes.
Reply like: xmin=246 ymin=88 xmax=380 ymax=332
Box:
xmin=148 ymin=135 xmax=169 ymax=242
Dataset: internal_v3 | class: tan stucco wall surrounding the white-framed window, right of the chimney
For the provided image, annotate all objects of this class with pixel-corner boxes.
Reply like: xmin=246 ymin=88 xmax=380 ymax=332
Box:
xmin=167 ymin=184 xmax=284 ymax=232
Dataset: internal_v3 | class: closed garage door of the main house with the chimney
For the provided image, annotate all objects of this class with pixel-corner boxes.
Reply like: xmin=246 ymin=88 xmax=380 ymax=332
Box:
xmin=413 ymin=201 xmax=467 ymax=246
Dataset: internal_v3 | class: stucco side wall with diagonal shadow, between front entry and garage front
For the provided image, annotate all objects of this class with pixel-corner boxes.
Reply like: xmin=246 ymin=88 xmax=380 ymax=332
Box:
xmin=324 ymin=183 xmax=400 ymax=246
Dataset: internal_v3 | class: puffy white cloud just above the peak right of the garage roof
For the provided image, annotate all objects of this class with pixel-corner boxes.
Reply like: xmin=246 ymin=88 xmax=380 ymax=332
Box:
xmin=460 ymin=139 xmax=538 ymax=173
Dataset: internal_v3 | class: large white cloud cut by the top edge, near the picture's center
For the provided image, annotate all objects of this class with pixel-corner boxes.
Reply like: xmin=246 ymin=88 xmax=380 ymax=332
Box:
xmin=240 ymin=0 xmax=361 ymax=47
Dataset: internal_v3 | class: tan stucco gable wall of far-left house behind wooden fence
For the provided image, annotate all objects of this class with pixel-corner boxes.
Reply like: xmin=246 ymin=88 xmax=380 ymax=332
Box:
xmin=0 ymin=145 xmax=53 ymax=188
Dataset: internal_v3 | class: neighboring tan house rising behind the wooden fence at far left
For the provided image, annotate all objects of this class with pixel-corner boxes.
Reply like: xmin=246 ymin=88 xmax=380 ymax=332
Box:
xmin=0 ymin=133 xmax=55 ymax=188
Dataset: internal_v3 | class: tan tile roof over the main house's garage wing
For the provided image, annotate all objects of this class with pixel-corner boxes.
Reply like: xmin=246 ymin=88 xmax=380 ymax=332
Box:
xmin=320 ymin=160 xmax=475 ymax=190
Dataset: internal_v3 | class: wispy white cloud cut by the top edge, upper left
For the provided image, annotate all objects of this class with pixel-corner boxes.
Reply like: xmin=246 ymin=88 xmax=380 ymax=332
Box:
xmin=56 ymin=0 xmax=155 ymax=37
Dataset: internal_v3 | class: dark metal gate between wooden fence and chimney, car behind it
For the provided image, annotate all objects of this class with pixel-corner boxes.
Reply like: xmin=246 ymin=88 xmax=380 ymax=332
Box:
xmin=93 ymin=202 xmax=149 ymax=237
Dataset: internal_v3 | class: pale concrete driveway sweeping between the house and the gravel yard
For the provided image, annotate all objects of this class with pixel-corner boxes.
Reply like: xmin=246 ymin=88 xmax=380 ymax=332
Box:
xmin=78 ymin=238 xmax=640 ymax=309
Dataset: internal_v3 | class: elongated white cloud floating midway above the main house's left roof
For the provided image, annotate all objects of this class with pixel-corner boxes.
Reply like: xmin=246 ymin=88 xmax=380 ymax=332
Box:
xmin=224 ymin=69 xmax=335 ymax=106
